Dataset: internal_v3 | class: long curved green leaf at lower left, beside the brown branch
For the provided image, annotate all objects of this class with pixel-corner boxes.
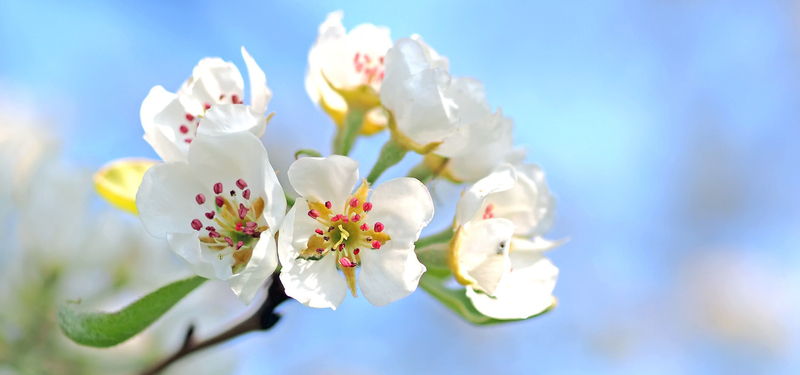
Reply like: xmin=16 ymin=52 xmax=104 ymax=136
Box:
xmin=58 ymin=276 xmax=206 ymax=348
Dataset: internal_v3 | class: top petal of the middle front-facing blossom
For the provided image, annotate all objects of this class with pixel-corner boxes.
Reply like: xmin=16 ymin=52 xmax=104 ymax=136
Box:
xmin=287 ymin=155 xmax=358 ymax=206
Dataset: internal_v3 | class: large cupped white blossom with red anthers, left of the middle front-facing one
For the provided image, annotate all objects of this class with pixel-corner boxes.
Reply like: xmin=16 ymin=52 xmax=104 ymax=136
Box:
xmin=136 ymin=108 xmax=286 ymax=304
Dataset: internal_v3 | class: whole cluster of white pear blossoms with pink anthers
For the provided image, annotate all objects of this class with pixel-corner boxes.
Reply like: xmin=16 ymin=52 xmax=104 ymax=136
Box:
xmin=125 ymin=12 xmax=560 ymax=320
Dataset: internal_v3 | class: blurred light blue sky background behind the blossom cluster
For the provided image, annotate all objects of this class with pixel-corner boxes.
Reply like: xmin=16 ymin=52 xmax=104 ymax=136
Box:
xmin=0 ymin=0 xmax=800 ymax=374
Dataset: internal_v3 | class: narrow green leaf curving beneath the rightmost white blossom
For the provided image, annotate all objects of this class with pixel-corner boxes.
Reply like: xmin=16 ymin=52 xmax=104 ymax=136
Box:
xmin=419 ymin=272 xmax=555 ymax=325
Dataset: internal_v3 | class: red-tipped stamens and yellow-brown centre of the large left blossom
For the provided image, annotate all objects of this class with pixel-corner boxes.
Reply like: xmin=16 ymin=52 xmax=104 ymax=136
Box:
xmin=191 ymin=179 xmax=269 ymax=273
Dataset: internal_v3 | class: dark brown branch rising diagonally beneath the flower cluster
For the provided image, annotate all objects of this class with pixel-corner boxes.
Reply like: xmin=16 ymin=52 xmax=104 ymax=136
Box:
xmin=142 ymin=273 xmax=289 ymax=375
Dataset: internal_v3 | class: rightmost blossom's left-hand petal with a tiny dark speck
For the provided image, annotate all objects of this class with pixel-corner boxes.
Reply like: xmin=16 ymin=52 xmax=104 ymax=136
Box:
xmin=457 ymin=219 xmax=514 ymax=295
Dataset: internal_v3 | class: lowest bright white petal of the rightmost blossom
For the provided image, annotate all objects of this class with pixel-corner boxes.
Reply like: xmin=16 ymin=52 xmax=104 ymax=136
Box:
xmin=467 ymin=252 xmax=558 ymax=319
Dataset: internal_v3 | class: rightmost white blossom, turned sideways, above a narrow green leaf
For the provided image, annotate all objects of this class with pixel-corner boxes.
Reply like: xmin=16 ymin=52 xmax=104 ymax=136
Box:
xmin=450 ymin=164 xmax=559 ymax=319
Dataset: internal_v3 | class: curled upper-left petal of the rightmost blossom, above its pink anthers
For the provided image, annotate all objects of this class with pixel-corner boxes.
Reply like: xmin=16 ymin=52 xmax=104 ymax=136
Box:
xmin=456 ymin=164 xmax=517 ymax=225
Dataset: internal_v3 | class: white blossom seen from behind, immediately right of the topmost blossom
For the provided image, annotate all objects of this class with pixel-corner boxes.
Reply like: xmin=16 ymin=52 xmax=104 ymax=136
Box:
xmin=380 ymin=37 xmax=459 ymax=146
